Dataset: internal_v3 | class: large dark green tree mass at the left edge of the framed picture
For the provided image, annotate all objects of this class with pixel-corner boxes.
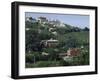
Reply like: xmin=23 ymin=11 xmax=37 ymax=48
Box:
xmin=25 ymin=29 xmax=41 ymax=52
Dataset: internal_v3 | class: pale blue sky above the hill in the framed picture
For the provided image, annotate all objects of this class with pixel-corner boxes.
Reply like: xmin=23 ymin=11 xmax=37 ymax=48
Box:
xmin=25 ymin=12 xmax=89 ymax=28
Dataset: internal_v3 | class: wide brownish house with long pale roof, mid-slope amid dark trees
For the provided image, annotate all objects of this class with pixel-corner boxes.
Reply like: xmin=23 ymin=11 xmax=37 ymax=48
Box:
xmin=41 ymin=39 xmax=58 ymax=47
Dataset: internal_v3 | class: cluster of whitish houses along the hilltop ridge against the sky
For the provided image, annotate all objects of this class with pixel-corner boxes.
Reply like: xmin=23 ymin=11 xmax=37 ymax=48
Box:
xmin=25 ymin=17 xmax=65 ymax=27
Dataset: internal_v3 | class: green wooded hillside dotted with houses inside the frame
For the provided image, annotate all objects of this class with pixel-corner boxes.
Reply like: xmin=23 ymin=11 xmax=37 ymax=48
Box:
xmin=25 ymin=16 xmax=89 ymax=68
